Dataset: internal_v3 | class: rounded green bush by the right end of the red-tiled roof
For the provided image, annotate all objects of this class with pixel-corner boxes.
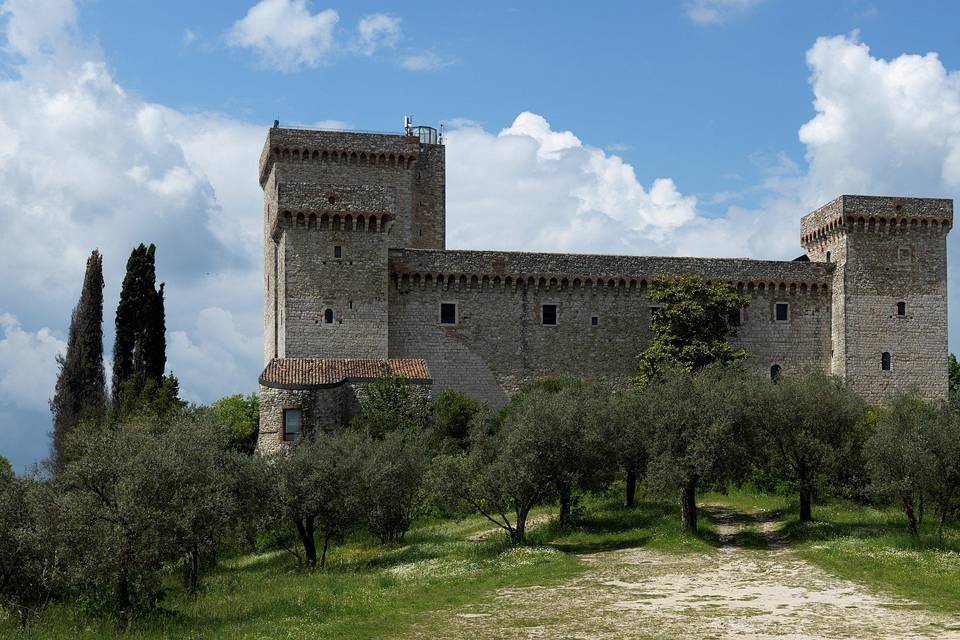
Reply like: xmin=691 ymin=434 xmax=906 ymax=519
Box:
xmin=351 ymin=368 xmax=430 ymax=439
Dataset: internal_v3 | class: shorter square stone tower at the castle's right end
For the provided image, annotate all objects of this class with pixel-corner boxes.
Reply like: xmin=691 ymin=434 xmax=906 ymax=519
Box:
xmin=800 ymin=195 xmax=953 ymax=402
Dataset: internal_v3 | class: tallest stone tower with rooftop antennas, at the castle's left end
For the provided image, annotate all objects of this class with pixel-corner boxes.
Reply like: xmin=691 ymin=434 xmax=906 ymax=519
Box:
xmin=260 ymin=120 xmax=446 ymax=362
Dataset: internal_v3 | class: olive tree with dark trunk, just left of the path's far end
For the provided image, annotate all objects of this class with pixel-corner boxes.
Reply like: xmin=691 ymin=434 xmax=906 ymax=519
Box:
xmin=645 ymin=366 xmax=748 ymax=532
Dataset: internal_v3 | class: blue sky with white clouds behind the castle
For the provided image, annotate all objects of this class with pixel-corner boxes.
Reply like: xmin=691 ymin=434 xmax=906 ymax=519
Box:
xmin=0 ymin=0 xmax=960 ymax=471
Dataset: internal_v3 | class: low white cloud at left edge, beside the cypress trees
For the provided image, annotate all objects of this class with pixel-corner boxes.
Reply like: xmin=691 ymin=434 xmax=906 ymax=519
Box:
xmin=0 ymin=313 xmax=66 ymax=410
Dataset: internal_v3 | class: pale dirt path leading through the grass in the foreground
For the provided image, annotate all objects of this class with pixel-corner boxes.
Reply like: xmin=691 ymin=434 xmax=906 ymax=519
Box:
xmin=408 ymin=507 xmax=960 ymax=640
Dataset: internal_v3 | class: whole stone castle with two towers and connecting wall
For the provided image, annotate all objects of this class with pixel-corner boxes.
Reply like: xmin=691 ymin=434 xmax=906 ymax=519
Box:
xmin=258 ymin=123 xmax=953 ymax=451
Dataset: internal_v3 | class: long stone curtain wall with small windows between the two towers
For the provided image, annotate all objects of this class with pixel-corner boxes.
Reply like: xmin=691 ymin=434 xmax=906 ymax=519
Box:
xmin=389 ymin=250 xmax=831 ymax=405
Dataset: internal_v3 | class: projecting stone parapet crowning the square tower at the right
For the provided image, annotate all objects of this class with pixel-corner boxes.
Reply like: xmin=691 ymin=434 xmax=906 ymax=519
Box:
xmin=800 ymin=195 xmax=953 ymax=245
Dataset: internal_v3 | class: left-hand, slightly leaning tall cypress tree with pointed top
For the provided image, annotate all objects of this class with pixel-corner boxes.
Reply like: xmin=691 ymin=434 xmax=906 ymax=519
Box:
xmin=50 ymin=250 xmax=107 ymax=469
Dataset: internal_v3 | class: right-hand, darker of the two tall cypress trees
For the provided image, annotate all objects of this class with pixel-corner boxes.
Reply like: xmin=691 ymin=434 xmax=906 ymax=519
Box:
xmin=112 ymin=244 xmax=166 ymax=403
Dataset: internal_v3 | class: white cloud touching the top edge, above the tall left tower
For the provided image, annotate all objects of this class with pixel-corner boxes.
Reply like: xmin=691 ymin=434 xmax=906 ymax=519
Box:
xmin=227 ymin=0 xmax=340 ymax=71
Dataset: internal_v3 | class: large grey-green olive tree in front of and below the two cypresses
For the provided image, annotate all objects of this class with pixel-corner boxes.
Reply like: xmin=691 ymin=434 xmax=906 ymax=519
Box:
xmin=60 ymin=414 xmax=246 ymax=616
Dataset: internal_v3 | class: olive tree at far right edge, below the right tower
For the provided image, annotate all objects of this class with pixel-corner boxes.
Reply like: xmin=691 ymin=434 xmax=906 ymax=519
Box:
xmin=866 ymin=394 xmax=960 ymax=541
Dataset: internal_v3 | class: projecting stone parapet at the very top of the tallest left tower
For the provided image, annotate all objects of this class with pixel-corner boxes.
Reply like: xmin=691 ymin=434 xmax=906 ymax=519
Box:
xmin=259 ymin=127 xmax=436 ymax=187
